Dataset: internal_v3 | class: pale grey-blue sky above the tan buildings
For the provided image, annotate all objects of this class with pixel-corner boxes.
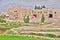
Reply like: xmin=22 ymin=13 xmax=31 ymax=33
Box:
xmin=0 ymin=0 xmax=60 ymax=11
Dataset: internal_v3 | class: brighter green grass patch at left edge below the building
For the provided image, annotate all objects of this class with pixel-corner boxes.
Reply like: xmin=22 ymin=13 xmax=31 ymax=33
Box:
xmin=0 ymin=22 xmax=22 ymax=28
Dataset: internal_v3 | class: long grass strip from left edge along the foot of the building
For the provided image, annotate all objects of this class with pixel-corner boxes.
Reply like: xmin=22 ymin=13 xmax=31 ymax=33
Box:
xmin=0 ymin=22 xmax=50 ymax=28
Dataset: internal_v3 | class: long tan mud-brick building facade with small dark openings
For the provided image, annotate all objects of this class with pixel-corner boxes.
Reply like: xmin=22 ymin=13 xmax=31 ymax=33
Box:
xmin=6 ymin=7 xmax=60 ymax=22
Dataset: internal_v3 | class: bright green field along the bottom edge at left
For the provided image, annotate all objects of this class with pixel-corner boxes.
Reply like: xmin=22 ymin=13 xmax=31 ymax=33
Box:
xmin=0 ymin=36 xmax=49 ymax=40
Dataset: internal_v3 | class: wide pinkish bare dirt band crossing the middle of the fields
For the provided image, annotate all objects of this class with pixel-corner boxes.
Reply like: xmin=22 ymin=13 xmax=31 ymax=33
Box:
xmin=12 ymin=26 xmax=60 ymax=31
